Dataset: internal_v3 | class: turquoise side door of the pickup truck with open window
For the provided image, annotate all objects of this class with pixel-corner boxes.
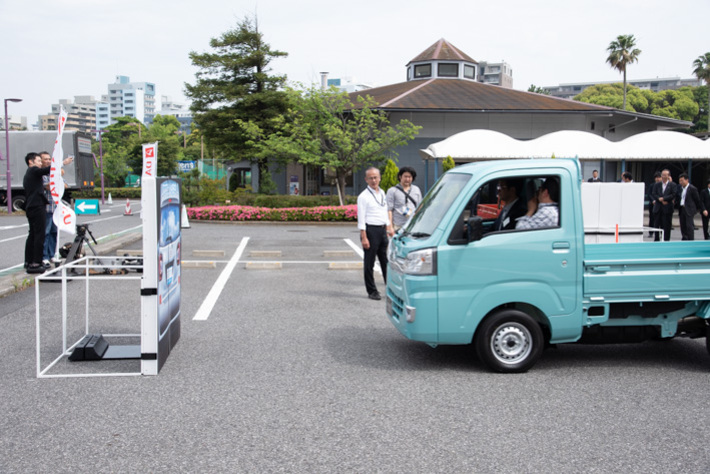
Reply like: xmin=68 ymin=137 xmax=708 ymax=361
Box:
xmin=437 ymin=170 xmax=581 ymax=342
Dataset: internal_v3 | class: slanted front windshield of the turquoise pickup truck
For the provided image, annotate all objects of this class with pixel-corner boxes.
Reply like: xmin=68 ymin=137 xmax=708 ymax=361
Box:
xmin=404 ymin=172 xmax=471 ymax=237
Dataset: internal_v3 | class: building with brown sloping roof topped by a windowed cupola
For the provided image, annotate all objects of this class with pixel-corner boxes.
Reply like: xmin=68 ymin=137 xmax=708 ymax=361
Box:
xmin=272 ymin=38 xmax=692 ymax=195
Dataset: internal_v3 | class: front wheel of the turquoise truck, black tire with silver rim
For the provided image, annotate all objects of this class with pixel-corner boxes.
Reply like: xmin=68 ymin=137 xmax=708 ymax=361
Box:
xmin=474 ymin=309 xmax=545 ymax=373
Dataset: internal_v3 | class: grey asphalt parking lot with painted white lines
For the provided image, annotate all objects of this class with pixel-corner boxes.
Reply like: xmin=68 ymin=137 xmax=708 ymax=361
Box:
xmin=0 ymin=223 xmax=710 ymax=473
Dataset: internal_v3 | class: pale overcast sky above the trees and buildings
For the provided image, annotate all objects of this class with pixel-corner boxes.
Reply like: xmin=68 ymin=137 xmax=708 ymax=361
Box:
xmin=0 ymin=0 xmax=710 ymax=123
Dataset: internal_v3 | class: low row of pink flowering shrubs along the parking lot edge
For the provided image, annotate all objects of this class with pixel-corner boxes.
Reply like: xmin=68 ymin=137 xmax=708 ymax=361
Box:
xmin=187 ymin=204 xmax=357 ymax=222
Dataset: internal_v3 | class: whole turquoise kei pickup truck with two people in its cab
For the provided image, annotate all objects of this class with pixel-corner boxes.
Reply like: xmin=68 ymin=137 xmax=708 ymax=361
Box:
xmin=386 ymin=159 xmax=710 ymax=372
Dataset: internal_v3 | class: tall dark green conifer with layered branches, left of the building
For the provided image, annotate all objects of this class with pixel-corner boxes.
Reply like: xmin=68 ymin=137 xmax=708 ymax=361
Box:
xmin=185 ymin=17 xmax=287 ymax=192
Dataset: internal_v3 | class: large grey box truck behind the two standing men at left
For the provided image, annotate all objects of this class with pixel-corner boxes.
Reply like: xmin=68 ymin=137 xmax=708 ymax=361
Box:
xmin=0 ymin=130 xmax=94 ymax=211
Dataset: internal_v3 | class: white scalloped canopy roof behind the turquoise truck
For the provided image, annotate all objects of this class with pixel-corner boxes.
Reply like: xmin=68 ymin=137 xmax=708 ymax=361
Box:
xmin=419 ymin=130 xmax=710 ymax=162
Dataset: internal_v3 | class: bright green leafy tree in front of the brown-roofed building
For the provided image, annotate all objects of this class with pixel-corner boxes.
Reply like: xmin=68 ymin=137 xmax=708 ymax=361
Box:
xmin=240 ymin=88 xmax=421 ymax=205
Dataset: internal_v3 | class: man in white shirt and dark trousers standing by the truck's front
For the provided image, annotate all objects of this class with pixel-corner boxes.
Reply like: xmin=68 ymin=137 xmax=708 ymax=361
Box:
xmin=357 ymin=166 xmax=394 ymax=300
